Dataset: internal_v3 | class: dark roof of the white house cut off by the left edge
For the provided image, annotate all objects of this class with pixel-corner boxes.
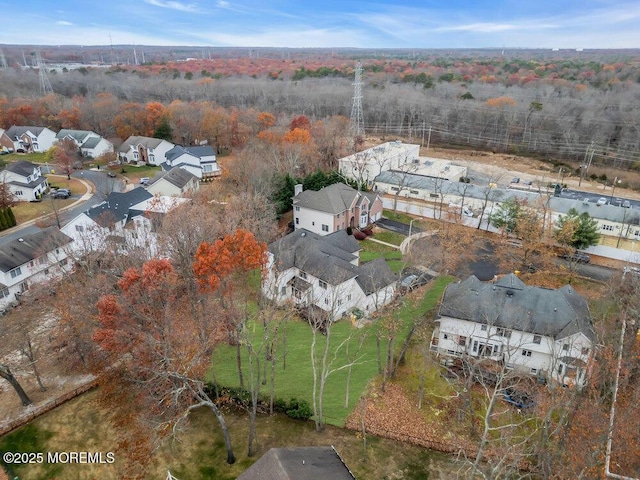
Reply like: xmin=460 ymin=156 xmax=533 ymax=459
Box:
xmin=0 ymin=227 xmax=71 ymax=272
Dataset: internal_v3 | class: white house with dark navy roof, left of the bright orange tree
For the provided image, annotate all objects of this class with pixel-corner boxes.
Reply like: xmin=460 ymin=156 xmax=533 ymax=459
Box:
xmin=62 ymin=187 xmax=188 ymax=258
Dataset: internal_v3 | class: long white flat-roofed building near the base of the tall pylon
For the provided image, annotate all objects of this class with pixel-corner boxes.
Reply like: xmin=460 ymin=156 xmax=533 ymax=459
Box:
xmin=338 ymin=141 xmax=420 ymax=187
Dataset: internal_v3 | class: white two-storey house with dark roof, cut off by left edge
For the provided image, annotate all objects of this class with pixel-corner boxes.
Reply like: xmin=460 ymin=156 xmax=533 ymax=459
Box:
xmin=0 ymin=227 xmax=73 ymax=310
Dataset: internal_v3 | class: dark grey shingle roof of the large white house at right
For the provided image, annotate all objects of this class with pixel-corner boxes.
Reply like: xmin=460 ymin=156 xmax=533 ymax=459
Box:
xmin=439 ymin=273 xmax=595 ymax=340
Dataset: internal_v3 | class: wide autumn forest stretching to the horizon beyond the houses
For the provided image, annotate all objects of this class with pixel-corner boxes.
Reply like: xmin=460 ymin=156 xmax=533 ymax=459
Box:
xmin=0 ymin=50 xmax=640 ymax=176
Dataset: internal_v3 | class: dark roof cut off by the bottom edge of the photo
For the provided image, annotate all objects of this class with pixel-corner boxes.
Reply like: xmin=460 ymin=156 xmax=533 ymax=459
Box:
xmin=238 ymin=447 xmax=355 ymax=480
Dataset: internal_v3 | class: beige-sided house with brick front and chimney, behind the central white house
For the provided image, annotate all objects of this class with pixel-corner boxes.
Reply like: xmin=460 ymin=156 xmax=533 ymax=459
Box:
xmin=293 ymin=183 xmax=382 ymax=235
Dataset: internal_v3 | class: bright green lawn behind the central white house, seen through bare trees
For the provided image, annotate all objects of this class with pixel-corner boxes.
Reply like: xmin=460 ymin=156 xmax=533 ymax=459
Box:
xmin=211 ymin=277 xmax=452 ymax=426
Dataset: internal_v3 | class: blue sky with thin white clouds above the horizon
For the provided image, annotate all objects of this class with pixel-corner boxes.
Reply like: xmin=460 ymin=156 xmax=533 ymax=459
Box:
xmin=0 ymin=0 xmax=640 ymax=49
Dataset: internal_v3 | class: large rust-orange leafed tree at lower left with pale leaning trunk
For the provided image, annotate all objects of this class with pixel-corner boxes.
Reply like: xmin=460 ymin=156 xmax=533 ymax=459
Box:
xmin=93 ymin=260 xmax=240 ymax=475
